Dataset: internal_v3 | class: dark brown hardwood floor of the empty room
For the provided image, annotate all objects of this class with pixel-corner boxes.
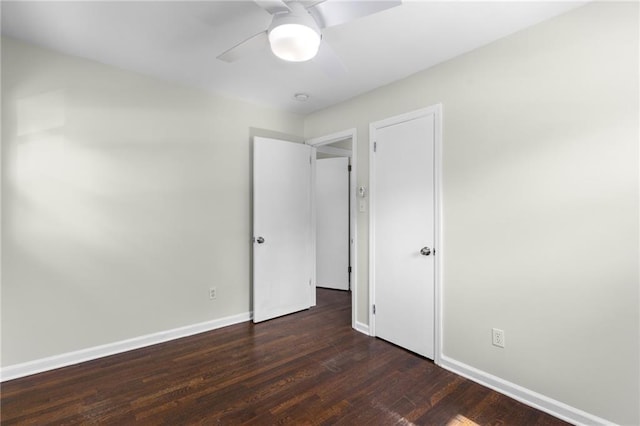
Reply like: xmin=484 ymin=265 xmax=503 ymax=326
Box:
xmin=1 ymin=289 xmax=566 ymax=425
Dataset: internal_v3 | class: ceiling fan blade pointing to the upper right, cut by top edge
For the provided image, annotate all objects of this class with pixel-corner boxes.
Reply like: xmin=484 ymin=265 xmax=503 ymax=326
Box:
xmin=307 ymin=0 xmax=402 ymax=28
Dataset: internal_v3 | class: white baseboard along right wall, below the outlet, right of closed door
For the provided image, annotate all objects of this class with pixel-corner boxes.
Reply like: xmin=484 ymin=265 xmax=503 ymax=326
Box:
xmin=439 ymin=355 xmax=614 ymax=426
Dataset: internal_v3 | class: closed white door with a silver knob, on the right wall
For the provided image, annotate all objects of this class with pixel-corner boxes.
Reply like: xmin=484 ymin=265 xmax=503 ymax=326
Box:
xmin=371 ymin=110 xmax=436 ymax=359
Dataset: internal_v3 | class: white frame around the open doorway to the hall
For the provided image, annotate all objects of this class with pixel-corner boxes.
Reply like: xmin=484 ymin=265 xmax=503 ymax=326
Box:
xmin=305 ymin=128 xmax=360 ymax=331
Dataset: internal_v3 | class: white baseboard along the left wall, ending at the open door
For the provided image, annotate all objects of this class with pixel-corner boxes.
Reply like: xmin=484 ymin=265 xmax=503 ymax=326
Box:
xmin=0 ymin=312 xmax=252 ymax=382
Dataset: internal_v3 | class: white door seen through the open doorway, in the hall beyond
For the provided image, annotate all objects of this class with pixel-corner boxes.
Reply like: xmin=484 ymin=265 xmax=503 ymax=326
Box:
xmin=316 ymin=157 xmax=349 ymax=290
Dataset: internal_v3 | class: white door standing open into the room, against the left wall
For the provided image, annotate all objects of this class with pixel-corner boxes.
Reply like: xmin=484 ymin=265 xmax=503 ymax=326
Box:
xmin=253 ymin=137 xmax=315 ymax=322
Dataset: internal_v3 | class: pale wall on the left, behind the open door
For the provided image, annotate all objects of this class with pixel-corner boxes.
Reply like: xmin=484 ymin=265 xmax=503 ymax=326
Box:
xmin=2 ymin=39 xmax=303 ymax=366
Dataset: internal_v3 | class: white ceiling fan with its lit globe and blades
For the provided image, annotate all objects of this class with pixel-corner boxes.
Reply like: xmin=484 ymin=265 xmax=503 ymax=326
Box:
xmin=217 ymin=0 xmax=402 ymax=77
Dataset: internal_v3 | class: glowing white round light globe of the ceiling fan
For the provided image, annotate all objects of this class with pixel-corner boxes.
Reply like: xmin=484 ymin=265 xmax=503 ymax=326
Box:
xmin=269 ymin=24 xmax=321 ymax=62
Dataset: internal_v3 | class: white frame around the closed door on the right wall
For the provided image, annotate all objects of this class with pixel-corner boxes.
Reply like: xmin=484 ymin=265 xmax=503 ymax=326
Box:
xmin=369 ymin=104 xmax=444 ymax=364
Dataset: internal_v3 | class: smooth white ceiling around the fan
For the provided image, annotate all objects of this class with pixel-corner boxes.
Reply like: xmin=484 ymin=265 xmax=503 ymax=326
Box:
xmin=1 ymin=0 xmax=585 ymax=114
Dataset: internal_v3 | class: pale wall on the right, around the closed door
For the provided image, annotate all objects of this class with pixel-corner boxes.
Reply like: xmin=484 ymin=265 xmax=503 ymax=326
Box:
xmin=305 ymin=2 xmax=640 ymax=425
